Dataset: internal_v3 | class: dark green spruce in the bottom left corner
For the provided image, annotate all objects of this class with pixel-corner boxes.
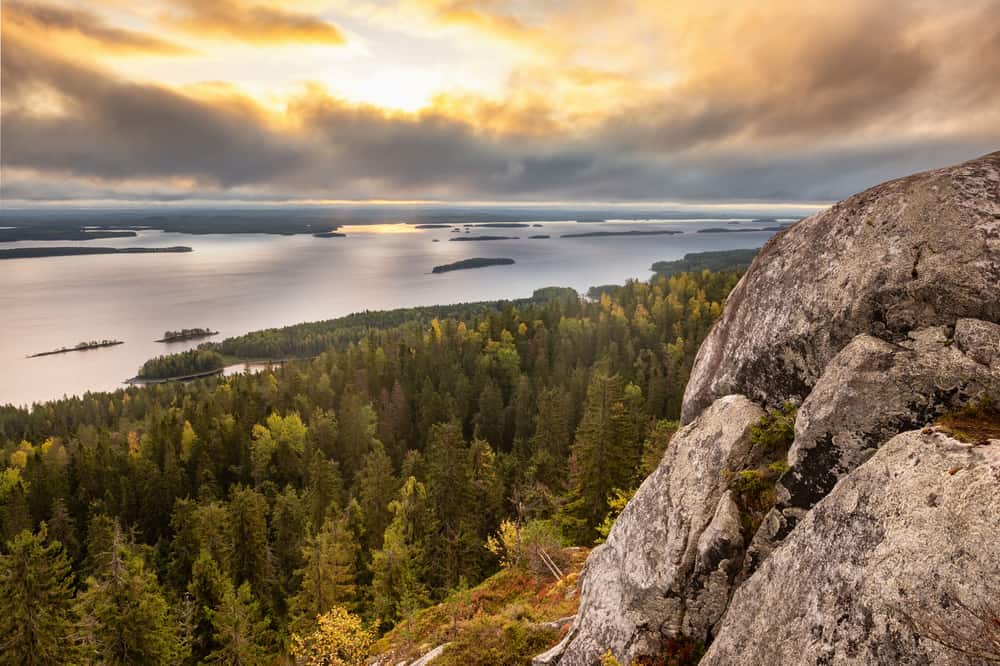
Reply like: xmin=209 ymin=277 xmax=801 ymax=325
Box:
xmin=0 ymin=523 xmax=78 ymax=665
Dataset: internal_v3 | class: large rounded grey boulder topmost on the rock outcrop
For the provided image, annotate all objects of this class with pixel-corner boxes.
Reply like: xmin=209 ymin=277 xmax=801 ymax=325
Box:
xmin=682 ymin=152 xmax=1000 ymax=423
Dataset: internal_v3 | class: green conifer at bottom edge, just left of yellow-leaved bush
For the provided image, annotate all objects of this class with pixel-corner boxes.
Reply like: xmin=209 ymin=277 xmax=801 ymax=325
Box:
xmin=205 ymin=582 xmax=270 ymax=666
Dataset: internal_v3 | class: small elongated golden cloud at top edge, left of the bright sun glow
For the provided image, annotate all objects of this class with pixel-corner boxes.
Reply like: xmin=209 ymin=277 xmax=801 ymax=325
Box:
xmin=166 ymin=0 xmax=346 ymax=45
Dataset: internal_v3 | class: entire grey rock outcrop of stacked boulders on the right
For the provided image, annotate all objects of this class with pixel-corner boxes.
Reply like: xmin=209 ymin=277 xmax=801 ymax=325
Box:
xmin=536 ymin=153 xmax=1000 ymax=666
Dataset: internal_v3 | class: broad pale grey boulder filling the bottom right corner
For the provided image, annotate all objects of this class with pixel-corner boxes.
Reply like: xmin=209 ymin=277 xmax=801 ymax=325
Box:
xmin=701 ymin=429 xmax=1000 ymax=666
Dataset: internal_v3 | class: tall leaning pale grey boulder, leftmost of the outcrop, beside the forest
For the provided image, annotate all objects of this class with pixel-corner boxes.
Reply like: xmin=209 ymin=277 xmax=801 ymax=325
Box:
xmin=536 ymin=395 xmax=764 ymax=666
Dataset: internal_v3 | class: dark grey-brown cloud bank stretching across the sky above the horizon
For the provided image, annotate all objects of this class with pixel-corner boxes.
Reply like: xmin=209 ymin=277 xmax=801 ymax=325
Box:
xmin=0 ymin=6 xmax=1000 ymax=201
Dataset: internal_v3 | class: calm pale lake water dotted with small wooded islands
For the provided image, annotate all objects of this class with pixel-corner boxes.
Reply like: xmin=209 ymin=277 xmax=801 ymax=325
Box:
xmin=0 ymin=219 xmax=773 ymax=405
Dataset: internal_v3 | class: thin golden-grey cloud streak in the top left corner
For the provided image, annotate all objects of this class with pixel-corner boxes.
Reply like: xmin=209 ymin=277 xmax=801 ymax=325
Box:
xmin=3 ymin=0 xmax=193 ymax=55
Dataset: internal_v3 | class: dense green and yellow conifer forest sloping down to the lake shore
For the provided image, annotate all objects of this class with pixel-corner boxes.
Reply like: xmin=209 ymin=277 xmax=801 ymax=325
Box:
xmin=0 ymin=270 xmax=739 ymax=664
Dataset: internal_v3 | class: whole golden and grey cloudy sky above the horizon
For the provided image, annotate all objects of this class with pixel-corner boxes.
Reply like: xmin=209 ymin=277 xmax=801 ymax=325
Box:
xmin=0 ymin=0 xmax=1000 ymax=206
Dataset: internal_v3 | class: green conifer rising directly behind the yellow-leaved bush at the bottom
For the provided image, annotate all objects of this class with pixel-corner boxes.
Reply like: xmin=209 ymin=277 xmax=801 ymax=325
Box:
xmin=289 ymin=514 xmax=358 ymax=633
